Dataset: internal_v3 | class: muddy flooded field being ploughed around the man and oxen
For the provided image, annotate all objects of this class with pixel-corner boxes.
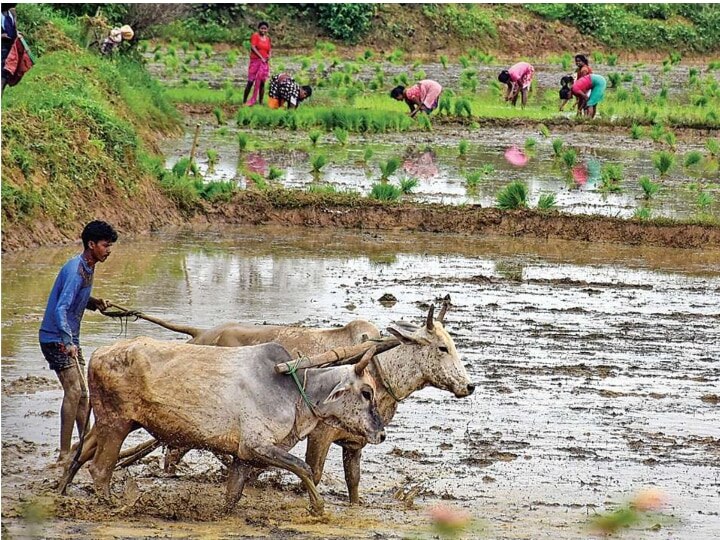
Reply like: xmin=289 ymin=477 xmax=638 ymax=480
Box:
xmin=2 ymin=228 xmax=720 ymax=538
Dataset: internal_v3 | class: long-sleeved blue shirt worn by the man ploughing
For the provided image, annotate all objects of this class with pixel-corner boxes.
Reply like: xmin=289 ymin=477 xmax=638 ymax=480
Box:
xmin=40 ymin=254 xmax=93 ymax=345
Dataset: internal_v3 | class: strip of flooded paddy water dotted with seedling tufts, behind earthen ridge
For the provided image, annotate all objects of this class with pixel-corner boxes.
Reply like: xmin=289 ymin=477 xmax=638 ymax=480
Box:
xmin=162 ymin=115 xmax=720 ymax=219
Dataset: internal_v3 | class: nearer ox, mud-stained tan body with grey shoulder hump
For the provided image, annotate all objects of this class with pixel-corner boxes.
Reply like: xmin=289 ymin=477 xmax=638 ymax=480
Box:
xmin=82 ymin=337 xmax=385 ymax=513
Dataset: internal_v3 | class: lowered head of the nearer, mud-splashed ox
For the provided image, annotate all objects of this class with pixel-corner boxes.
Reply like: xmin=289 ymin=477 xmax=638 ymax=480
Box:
xmin=322 ymin=355 xmax=385 ymax=444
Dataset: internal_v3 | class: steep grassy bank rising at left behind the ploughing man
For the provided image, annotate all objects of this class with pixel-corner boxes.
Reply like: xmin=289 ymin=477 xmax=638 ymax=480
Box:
xmin=2 ymin=4 xmax=179 ymax=245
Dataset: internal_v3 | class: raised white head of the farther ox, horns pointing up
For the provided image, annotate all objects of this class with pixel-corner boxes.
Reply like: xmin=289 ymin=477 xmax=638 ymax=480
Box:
xmin=387 ymin=297 xmax=475 ymax=397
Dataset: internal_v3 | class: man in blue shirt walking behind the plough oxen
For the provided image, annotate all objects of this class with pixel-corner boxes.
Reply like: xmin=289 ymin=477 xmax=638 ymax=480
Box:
xmin=40 ymin=221 xmax=117 ymax=462
